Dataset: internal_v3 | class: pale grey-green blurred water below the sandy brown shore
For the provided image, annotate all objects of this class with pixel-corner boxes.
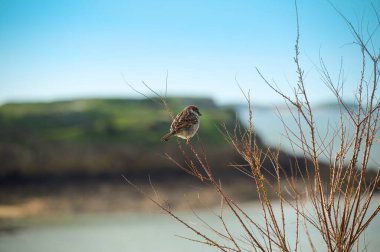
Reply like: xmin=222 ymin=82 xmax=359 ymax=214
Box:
xmin=0 ymin=195 xmax=380 ymax=252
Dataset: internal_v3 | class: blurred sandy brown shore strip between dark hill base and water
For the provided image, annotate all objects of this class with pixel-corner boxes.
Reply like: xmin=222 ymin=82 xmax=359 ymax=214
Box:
xmin=0 ymin=175 xmax=256 ymax=221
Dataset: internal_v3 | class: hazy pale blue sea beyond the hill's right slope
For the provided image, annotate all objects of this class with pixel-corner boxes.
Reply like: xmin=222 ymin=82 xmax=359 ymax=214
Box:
xmin=238 ymin=107 xmax=380 ymax=169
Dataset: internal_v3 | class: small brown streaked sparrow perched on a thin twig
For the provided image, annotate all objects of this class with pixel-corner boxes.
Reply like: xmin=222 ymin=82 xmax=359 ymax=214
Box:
xmin=161 ymin=105 xmax=202 ymax=143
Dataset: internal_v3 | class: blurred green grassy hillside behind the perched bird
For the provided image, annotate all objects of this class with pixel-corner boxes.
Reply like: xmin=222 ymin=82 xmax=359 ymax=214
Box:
xmin=0 ymin=98 xmax=243 ymax=179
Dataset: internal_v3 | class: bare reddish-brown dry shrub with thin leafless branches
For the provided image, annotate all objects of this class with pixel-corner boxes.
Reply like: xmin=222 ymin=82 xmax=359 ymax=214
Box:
xmin=125 ymin=1 xmax=380 ymax=251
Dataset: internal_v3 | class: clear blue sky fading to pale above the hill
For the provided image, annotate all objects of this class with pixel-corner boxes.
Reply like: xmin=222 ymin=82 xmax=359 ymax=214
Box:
xmin=0 ymin=0 xmax=380 ymax=104
